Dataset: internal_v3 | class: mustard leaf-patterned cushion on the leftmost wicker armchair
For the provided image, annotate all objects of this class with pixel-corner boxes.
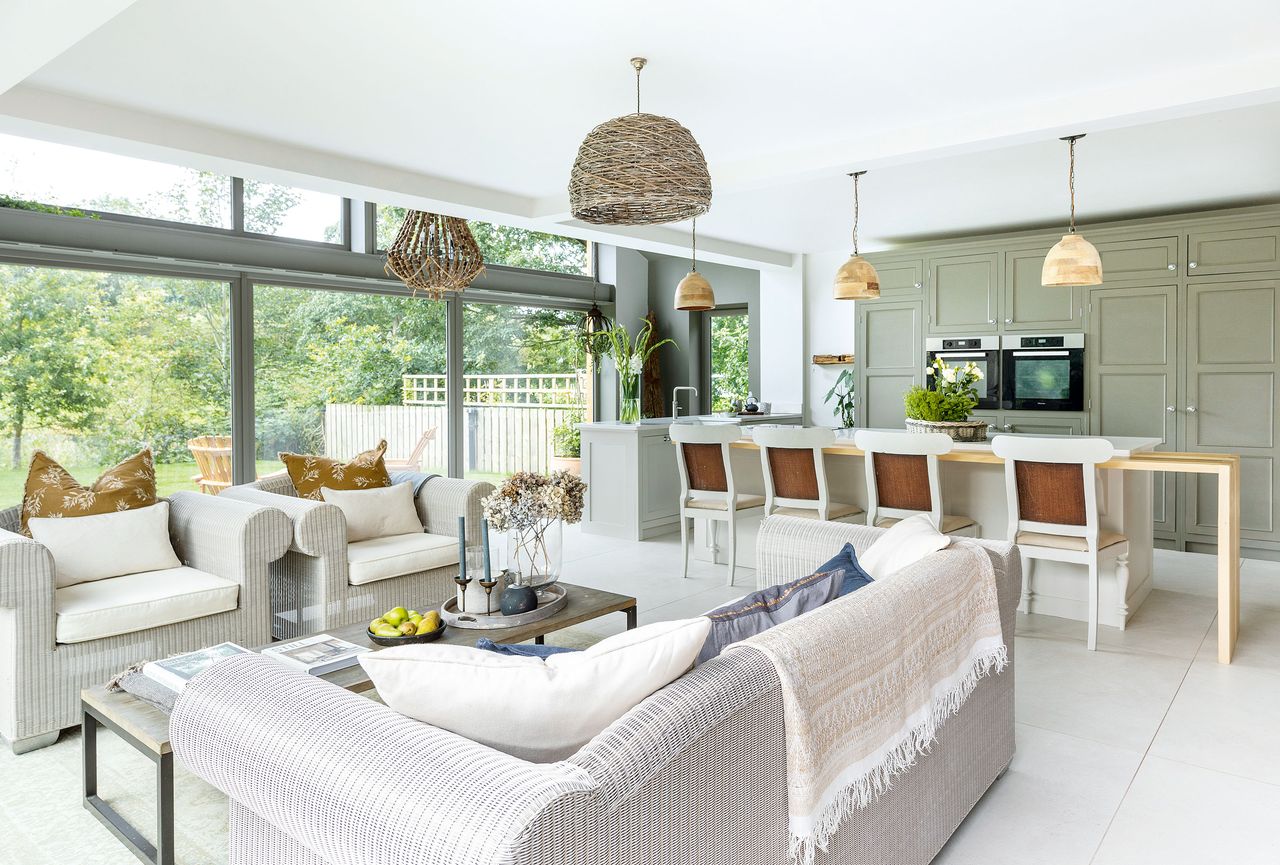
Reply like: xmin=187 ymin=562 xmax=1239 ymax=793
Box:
xmin=22 ymin=448 xmax=156 ymax=537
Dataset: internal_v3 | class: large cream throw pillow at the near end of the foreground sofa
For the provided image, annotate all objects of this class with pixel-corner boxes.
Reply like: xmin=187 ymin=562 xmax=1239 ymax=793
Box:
xmin=360 ymin=617 xmax=710 ymax=763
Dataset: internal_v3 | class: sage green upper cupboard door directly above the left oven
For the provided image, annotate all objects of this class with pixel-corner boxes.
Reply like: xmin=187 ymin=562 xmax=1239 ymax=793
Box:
xmin=925 ymin=252 xmax=1000 ymax=334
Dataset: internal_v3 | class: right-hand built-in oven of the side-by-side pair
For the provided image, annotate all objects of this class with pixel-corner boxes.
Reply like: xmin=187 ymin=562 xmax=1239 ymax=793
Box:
xmin=1002 ymin=334 xmax=1084 ymax=412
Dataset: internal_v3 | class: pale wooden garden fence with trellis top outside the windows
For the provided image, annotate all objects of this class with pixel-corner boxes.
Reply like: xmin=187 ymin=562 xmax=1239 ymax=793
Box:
xmin=324 ymin=374 xmax=586 ymax=475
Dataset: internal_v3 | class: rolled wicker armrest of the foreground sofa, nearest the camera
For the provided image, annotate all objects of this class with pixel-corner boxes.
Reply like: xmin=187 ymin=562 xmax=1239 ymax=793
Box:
xmin=169 ymin=655 xmax=594 ymax=865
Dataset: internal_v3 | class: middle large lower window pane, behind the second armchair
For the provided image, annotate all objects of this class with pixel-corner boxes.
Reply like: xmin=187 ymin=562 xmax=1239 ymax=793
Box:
xmin=253 ymin=284 xmax=448 ymax=475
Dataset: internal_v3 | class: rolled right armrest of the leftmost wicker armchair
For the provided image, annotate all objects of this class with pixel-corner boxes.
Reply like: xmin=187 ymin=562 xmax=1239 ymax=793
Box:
xmin=169 ymin=493 xmax=292 ymax=585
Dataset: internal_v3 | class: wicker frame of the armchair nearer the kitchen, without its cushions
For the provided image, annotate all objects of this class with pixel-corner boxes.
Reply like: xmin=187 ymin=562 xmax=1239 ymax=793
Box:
xmin=219 ymin=473 xmax=493 ymax=640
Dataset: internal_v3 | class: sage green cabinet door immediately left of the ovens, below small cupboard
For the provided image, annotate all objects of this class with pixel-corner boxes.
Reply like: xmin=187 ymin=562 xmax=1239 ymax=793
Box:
xmin=855 ymin=299 xmax=924 ymax=429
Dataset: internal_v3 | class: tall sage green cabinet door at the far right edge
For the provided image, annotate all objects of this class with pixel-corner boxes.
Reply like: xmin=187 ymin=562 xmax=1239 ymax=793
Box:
xmin=1183 ymin=279 xmax=1280 ymax=540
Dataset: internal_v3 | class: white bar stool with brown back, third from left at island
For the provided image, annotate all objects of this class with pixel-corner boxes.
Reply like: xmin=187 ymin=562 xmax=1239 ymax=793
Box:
xmin=854 ymin=430 xmax=980 ymax=537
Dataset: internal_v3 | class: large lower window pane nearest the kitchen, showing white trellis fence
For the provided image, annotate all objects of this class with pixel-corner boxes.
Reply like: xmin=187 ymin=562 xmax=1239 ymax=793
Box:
xmin=462 ymin=302 xmax=593 ymax=480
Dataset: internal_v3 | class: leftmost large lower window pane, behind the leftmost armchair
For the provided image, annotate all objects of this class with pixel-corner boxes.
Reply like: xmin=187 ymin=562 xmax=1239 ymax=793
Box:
xmin=0 ymin=264 xmax=232 ymax=496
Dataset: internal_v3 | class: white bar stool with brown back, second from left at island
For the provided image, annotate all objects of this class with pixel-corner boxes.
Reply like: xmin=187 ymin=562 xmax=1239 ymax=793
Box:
xmin=751 ymin=426 xmax=863 ymax=522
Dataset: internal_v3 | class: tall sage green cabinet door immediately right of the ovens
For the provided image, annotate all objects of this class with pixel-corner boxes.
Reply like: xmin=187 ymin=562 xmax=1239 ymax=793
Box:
xmin=1085 ymin=284 xmax=1180 ymax=537
